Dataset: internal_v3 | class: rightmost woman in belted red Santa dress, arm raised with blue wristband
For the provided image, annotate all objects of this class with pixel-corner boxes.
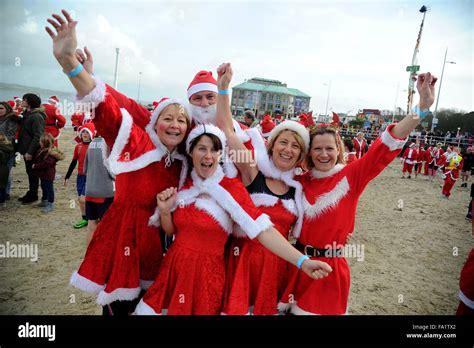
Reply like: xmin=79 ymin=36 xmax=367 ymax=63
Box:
xmin=282 ymin=73 xmax=436 ymax=315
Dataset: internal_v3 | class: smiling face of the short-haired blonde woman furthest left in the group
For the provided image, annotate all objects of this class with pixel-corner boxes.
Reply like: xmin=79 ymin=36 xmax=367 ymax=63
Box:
xmin=155 ymin=104 xmax=188 ymax=151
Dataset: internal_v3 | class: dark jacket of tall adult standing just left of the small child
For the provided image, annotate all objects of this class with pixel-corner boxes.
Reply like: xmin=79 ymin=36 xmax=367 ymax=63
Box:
xmin=17 ymin=109 xmax=46 ymax=157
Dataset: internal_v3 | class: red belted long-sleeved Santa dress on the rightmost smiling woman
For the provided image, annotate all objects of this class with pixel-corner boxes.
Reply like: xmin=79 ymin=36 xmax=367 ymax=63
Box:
xmin=281 ymin=125 xmax=406 ymax=315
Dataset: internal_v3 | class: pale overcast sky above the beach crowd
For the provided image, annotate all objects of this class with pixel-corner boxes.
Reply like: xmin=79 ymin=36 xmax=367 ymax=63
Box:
xmin=0 ymin=0 xmax=474 ymax=113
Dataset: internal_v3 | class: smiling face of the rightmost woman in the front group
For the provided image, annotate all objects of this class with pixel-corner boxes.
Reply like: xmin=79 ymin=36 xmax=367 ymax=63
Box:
xmin=310 ymin=133 xmax=340 ymax=172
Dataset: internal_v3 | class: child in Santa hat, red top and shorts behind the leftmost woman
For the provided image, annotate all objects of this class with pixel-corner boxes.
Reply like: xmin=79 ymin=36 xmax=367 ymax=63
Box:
xmin=64 ymin=122 xmax=95 ymax=229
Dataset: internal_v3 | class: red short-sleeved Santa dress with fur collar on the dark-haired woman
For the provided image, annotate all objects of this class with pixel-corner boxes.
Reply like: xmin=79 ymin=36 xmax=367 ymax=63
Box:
xmin=135 ymin=167 xmax=272 ymax=315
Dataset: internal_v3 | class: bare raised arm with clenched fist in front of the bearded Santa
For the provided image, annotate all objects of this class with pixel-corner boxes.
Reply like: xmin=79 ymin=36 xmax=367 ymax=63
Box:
xmin=217 ymin=63 xmax=258 ymax=186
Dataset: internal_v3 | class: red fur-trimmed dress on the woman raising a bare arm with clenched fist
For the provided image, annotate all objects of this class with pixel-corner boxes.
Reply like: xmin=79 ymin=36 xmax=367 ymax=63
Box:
xmin=223 ymin=129 xmax=303 ymax=315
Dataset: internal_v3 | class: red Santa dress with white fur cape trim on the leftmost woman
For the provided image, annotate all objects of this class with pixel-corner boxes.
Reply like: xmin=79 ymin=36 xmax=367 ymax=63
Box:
xmin=70 ymin=81 xmax=187 ymax=305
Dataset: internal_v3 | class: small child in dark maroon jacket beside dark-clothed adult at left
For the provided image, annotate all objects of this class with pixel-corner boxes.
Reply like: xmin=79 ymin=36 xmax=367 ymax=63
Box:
xmin=32 ymin=133 xmax=64 ymax=213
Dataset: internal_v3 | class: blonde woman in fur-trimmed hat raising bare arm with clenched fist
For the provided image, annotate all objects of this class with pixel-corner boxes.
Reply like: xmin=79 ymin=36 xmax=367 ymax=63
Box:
xmin=212 ymin=64 xmax=309 ymax=315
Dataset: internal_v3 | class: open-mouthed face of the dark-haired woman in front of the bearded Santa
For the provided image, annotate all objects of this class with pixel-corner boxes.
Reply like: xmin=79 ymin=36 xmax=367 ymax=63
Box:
xmin=190 ymin=135 xmax=222 ymax=179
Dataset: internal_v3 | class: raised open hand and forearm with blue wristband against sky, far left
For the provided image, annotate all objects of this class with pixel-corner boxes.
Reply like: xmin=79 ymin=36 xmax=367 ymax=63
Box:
xmin=45 ymin=10 xmax=95 ymax=97
